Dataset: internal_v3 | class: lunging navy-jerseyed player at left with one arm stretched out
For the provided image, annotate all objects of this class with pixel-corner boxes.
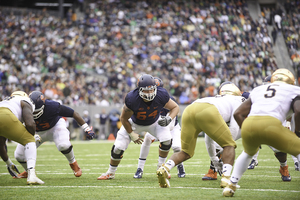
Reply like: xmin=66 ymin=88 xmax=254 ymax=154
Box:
xmin=15 ymin=91 xmax=95 ymax=178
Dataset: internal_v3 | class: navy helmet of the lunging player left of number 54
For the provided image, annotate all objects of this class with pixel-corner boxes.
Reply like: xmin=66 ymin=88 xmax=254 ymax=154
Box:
xmin=29 ymin=91 xmax=46 ymax=119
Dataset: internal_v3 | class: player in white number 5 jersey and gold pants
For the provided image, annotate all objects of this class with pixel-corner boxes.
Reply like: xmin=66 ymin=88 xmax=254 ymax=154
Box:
xmin=223 ymin=69 xmax=300 ymax=197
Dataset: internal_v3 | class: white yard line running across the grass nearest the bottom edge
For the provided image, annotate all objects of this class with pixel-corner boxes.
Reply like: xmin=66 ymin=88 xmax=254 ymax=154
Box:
xmin=0 ymin=185 xmax=300 ymax=193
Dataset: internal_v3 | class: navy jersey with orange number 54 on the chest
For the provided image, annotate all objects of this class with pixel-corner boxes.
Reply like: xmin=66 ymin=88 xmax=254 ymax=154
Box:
xmin=125 ymin=87 xmax=170 ymax=126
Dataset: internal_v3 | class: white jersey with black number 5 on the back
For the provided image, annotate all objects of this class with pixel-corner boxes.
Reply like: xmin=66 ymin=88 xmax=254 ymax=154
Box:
xmin=248 ymin=82 xmax=300 ymax=123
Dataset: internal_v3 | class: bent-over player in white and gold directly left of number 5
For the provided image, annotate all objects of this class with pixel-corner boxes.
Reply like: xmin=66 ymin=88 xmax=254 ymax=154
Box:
xmin=157 ymin=82 xmax=245 ymax=187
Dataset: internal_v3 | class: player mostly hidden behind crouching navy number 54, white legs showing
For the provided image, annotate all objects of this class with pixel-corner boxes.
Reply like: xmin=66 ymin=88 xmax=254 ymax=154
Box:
xmin=133 ymin=77 xmax=185 ymax=178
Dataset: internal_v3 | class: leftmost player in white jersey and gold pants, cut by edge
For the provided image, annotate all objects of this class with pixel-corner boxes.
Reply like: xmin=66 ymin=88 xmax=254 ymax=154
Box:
xmin=0 ymin=91 xmax=44 ymax=185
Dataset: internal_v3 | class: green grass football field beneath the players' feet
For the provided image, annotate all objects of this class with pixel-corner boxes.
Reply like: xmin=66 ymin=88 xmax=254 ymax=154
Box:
xmin=0 ymin=137 xmax=300 ymax=200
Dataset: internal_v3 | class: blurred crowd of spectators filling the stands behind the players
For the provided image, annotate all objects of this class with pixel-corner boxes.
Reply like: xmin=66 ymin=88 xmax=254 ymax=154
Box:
xmin=0 ymin=0 xmax=277 ymax=106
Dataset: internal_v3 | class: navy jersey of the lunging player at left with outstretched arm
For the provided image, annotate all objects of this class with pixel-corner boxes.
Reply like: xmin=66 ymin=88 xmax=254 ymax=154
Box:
xmin=34 ymin=99 xmax=74 ymax=132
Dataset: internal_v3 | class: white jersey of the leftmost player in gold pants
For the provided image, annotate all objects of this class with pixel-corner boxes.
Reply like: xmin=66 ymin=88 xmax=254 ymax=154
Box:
xmin=0 ymin=96 xmax=35 ymax=122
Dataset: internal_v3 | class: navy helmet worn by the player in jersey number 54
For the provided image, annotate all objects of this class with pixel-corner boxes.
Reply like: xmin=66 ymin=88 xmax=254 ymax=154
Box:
xmin=137 ymin=74 xmax=157 ymax=101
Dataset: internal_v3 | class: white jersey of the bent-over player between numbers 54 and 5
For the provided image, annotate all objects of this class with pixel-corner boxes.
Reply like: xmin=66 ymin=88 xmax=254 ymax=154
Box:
xmin=193 ymin=95 xmax=245 ymax=123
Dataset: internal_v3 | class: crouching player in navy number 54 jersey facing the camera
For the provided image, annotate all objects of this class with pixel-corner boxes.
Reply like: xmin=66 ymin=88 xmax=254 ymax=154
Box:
xmin=98 ymin=74 xmax=179 ymax=180
